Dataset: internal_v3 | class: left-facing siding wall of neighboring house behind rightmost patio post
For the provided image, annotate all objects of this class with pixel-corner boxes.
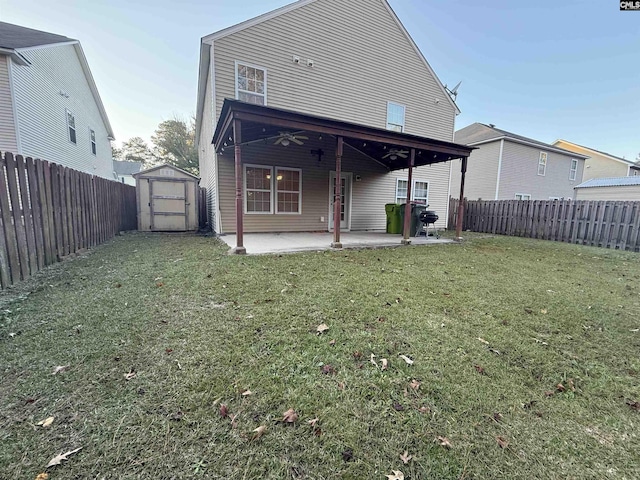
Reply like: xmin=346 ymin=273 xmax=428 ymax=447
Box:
xmin=451 ymin=141 xmax=501 ymax=200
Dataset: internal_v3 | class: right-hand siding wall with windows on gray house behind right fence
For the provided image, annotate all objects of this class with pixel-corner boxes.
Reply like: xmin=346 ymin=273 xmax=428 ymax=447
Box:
xmin=500 ymin=140 xmax=584 ymax=200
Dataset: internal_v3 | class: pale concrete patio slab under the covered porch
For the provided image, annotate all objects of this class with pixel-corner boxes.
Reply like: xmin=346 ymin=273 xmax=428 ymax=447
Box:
xmin=219 ymin=232 xmax=454 ymax=255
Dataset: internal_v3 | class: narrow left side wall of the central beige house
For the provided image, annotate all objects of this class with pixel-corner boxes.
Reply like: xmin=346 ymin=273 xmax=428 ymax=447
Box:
xmin=198 ymin=58 xmax=217 ymax=231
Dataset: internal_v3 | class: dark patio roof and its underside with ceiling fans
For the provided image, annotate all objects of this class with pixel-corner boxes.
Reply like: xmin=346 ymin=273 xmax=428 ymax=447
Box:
xmin=213 ymin=99 xmax=474 ymax=171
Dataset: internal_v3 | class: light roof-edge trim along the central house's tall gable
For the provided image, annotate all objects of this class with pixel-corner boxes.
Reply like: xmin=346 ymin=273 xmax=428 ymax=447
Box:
xmin=196 ymin=0 xmax=460 ymax=142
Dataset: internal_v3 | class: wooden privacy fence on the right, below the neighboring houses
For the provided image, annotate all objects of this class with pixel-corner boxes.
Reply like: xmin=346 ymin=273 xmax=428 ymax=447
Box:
xmin=449 ymin=198 xmax=640 ymax=252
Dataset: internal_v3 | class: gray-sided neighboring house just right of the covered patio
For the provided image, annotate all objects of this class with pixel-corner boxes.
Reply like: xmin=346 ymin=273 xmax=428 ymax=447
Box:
xmin=451 ymin=123 xmax=587 ymax=200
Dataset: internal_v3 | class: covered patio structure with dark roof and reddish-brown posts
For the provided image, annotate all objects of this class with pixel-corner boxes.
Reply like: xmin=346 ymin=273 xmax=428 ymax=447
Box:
xmin=213 ymin=99 xmax=473 ymax=254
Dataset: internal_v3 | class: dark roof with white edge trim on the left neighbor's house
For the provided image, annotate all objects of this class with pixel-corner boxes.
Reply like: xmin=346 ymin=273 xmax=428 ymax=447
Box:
xmin=0 ymin=22 xmax=115 ymax=140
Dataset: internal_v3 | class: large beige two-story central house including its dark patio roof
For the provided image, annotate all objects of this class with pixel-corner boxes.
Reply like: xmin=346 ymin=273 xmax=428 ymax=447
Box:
xmin=196 ymin=0 xmax=470 ymax=248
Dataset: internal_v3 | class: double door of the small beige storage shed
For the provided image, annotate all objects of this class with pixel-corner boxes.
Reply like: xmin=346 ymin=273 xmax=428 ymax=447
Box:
xmin=149 ymin=180 xmax=189 ymax=231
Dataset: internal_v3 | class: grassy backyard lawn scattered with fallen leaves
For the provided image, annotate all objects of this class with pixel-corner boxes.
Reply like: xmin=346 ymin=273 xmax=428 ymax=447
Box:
xmin=0 ymin=234 xmax=640 ymax=480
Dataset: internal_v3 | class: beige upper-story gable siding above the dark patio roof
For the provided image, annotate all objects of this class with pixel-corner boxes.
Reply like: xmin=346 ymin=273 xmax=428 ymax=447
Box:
xmin=214 ymin=0 xmax=455 ymax=141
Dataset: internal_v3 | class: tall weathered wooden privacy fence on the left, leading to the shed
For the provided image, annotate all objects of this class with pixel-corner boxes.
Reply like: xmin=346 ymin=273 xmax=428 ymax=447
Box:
xmin=0 ymin=152 xmax=137 ymax=288
